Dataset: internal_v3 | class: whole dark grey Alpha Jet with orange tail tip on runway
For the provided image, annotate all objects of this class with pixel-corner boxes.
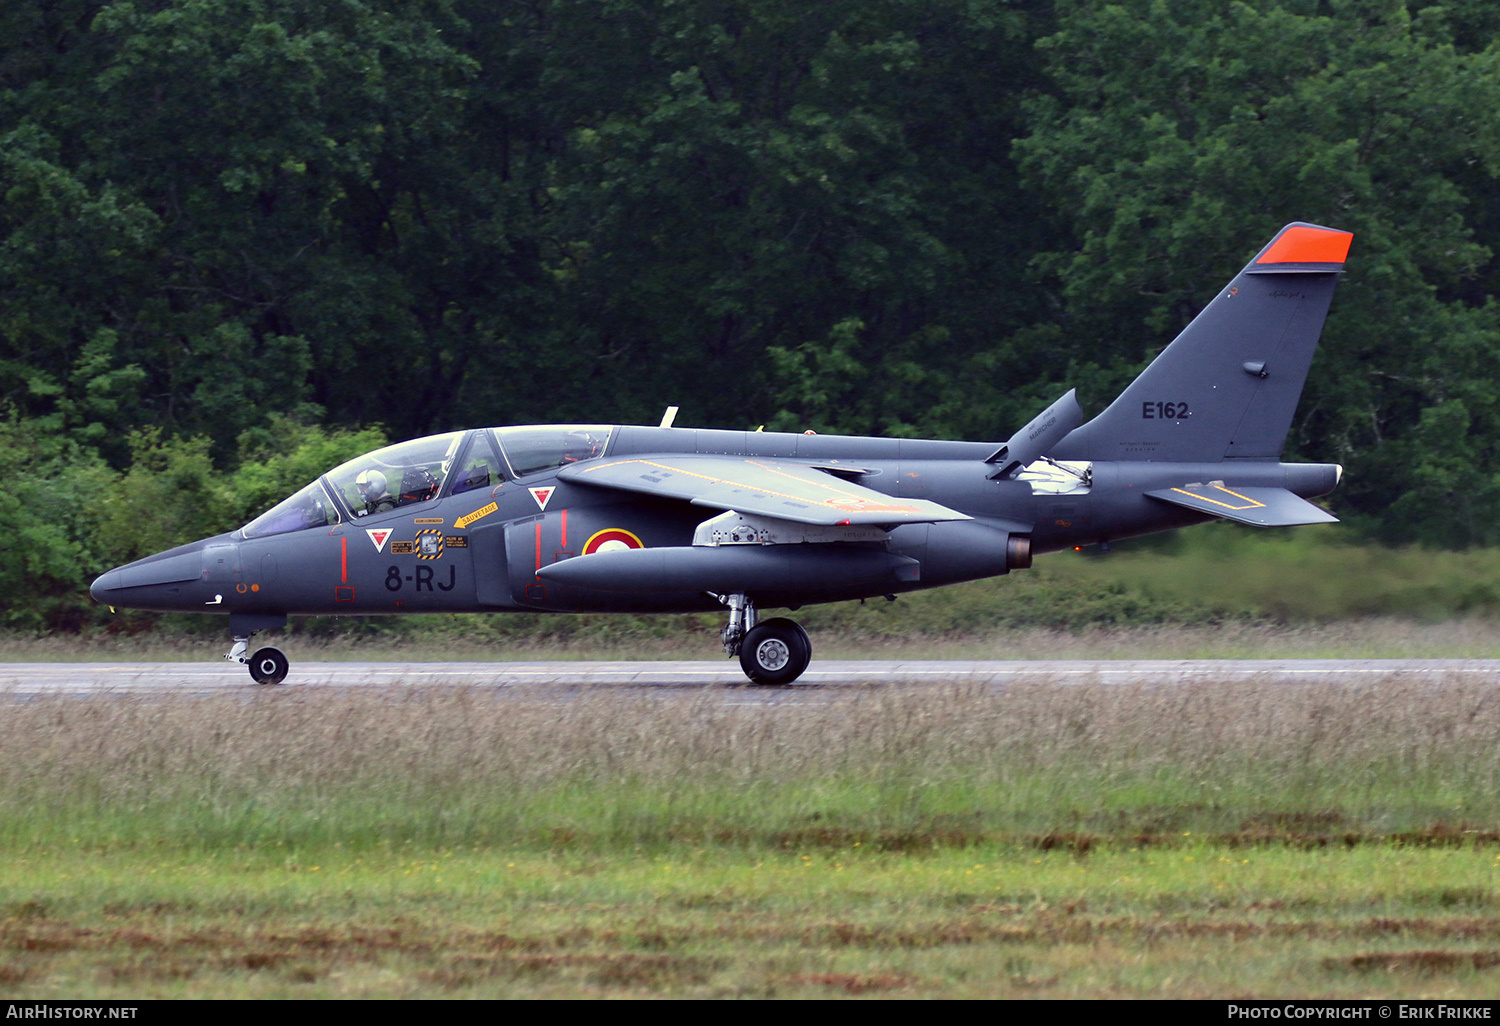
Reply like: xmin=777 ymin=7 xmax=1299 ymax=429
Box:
xmin=90 ymin=224 xmax=1352 ymax=684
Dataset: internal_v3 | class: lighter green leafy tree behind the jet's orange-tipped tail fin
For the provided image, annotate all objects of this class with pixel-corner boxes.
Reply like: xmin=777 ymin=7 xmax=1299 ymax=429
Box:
xmin=1017 ymin=0 xmax=1500 ymax=542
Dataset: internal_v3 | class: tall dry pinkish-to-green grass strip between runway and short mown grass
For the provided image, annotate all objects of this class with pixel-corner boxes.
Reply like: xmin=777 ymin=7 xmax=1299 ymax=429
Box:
xmin=0 ymin=677 xmax=1500 ymax=851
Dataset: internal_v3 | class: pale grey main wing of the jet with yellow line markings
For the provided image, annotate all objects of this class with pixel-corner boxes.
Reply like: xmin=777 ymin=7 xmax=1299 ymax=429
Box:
xmin=558 ymin=455 xmax=971 ymax=525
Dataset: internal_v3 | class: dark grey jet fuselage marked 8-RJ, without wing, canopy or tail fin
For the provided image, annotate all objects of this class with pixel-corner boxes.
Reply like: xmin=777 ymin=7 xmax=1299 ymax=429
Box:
xmin=92 ymin=426 xmax=1340 ymax=623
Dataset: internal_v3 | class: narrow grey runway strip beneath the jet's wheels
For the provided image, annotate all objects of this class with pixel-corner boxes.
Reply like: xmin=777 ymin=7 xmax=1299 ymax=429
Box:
xmin=0 ymin=659 xmax=1500 ymax=699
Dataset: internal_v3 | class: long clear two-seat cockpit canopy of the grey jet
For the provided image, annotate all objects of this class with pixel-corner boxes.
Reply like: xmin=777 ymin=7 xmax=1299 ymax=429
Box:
xmin=243 ymin=425 xmax=611 ymax=539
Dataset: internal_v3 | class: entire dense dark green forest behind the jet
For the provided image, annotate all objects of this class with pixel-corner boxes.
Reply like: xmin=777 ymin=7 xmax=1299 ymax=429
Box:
xmin=0 ymin=0 xmax=1500 ymax=629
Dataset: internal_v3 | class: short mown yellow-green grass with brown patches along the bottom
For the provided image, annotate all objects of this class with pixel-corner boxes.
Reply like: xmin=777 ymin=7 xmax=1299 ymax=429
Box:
xmin=0 ymin=843 xmax=1500 ymax=998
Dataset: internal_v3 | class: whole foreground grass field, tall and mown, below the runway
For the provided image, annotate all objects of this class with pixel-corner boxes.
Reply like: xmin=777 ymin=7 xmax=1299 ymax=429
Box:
xmin=0 ymin=677 xmax=1500 ymax=998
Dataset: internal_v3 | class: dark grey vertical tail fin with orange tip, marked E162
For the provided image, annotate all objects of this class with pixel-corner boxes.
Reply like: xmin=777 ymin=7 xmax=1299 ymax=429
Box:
xmin=1052 ymin=222 xmax=1353 ymax=462
